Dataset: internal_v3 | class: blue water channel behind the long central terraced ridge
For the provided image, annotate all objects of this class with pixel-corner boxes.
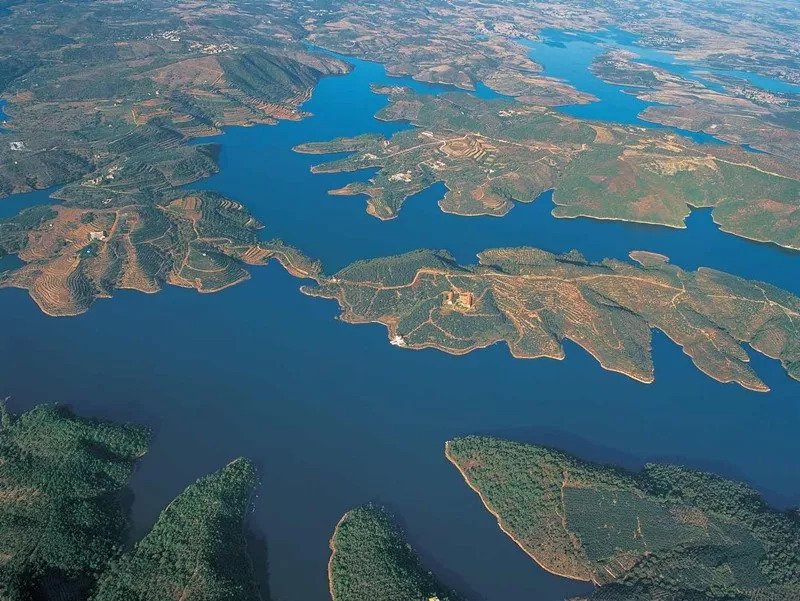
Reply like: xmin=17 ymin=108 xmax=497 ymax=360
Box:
xmin=190 ymin=52 xmax=800 ymax=294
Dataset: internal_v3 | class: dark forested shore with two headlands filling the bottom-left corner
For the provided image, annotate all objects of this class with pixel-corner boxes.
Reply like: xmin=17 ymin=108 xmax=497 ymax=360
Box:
xmin=0 ymin=405 xmax=261 ymax=601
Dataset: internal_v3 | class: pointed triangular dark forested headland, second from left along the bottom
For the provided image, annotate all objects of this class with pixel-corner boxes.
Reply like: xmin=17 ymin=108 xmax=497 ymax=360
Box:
xmin=92 ymin=459 xmax=261 ymax=601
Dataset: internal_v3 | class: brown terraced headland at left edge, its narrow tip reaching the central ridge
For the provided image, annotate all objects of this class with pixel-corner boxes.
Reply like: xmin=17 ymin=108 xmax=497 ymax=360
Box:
xmin=0 ymin=191 xmax=319 ymax=315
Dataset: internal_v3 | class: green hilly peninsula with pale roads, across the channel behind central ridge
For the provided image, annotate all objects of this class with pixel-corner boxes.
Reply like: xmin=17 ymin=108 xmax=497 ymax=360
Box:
xmin=296 ymin=88 xmax=800 ymax=248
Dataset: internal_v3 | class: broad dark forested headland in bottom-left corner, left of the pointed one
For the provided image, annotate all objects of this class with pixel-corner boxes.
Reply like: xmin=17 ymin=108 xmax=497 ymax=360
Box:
xmin=0 ymin=405 xmax=147 ymax=601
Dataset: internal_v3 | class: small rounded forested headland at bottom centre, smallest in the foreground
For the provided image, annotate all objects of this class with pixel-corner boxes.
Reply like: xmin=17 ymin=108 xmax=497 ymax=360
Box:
xmin=328 ymin=505 xmax=461 ymax=601
